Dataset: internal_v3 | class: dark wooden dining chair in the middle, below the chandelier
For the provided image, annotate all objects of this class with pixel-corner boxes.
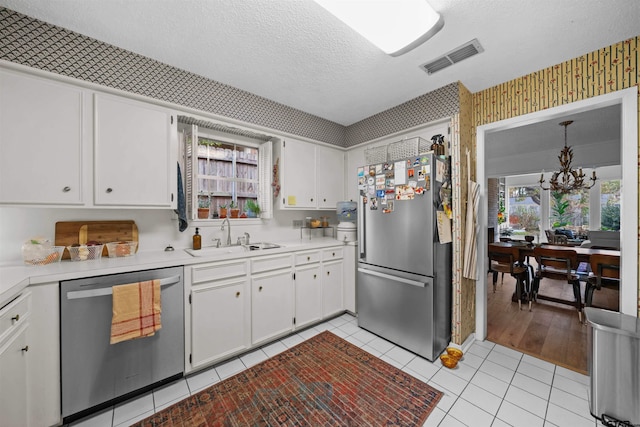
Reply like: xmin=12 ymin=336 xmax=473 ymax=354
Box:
xmin=531 ymin=246 xmax=582 ymax=322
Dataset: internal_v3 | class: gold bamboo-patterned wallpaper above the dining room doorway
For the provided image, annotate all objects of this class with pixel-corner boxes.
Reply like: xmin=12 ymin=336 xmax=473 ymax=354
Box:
xmin=470 ymin=36 xmax=640 ymax=320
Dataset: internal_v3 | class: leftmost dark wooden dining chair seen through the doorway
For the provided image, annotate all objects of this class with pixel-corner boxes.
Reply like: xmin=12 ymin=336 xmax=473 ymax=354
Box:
xmin=487 ymin=244 xmax=531 ymax=310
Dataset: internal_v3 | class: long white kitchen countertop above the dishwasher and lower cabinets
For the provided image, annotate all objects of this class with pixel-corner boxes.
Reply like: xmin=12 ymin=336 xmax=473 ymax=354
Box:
xmin=0 ymin=237 xmax=343 ymax=307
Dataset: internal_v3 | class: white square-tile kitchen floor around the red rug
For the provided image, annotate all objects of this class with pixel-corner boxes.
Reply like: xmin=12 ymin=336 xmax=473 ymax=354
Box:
xmin=72 ymin=314 xmax=602 ymax=427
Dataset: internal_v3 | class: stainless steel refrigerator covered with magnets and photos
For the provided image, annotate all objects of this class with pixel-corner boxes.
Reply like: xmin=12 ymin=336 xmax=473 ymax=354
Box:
xmin=356 ymin=153 xmax=452 ymax=361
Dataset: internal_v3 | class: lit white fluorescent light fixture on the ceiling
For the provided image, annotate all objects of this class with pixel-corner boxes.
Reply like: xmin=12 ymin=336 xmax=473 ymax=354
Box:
xmin=315 ymin=0 xmax=444 ymax=56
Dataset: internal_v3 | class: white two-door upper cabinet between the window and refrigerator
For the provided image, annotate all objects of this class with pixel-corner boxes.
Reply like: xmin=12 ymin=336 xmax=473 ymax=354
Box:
xmin=276 ymin=138 xmax=344 ymax=210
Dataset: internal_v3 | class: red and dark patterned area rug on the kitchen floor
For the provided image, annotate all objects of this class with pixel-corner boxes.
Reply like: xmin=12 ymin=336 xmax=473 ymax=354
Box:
xmin=134 ymin=331 xmax=442 ymax=427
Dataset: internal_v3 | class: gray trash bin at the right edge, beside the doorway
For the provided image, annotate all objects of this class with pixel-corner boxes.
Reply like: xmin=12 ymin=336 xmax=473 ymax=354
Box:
xmin=584 ymin=307 xmax=640 ymax=425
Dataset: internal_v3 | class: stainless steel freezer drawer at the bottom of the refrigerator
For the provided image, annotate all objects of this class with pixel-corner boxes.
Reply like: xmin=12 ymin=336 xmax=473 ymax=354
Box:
xmin=357 ymin=265 xmax=451 ymax=361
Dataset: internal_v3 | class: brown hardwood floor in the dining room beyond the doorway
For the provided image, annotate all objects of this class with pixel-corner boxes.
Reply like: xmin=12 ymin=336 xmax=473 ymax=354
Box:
xmin=487 ymin=274 xmax=618 ymax=374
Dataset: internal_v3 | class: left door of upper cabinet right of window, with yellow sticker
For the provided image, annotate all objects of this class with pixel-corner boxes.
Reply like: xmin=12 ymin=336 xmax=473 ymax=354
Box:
xmin=280 ymin=139 xmax=317 ymax=209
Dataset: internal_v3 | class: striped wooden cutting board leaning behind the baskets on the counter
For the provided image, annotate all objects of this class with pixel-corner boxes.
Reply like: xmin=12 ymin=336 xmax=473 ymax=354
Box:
xmin=55 ymin=220 xmax=138 ymax=259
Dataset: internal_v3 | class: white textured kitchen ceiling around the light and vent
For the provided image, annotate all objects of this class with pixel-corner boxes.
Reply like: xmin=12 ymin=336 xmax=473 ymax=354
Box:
xmin=0 ymin=0 xmax=640 ymax=125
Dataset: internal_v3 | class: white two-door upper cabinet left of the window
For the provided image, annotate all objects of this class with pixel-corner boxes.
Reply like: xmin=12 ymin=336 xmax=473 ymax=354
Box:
xmin=0 ymin=67 xmax=178 ymax=209
